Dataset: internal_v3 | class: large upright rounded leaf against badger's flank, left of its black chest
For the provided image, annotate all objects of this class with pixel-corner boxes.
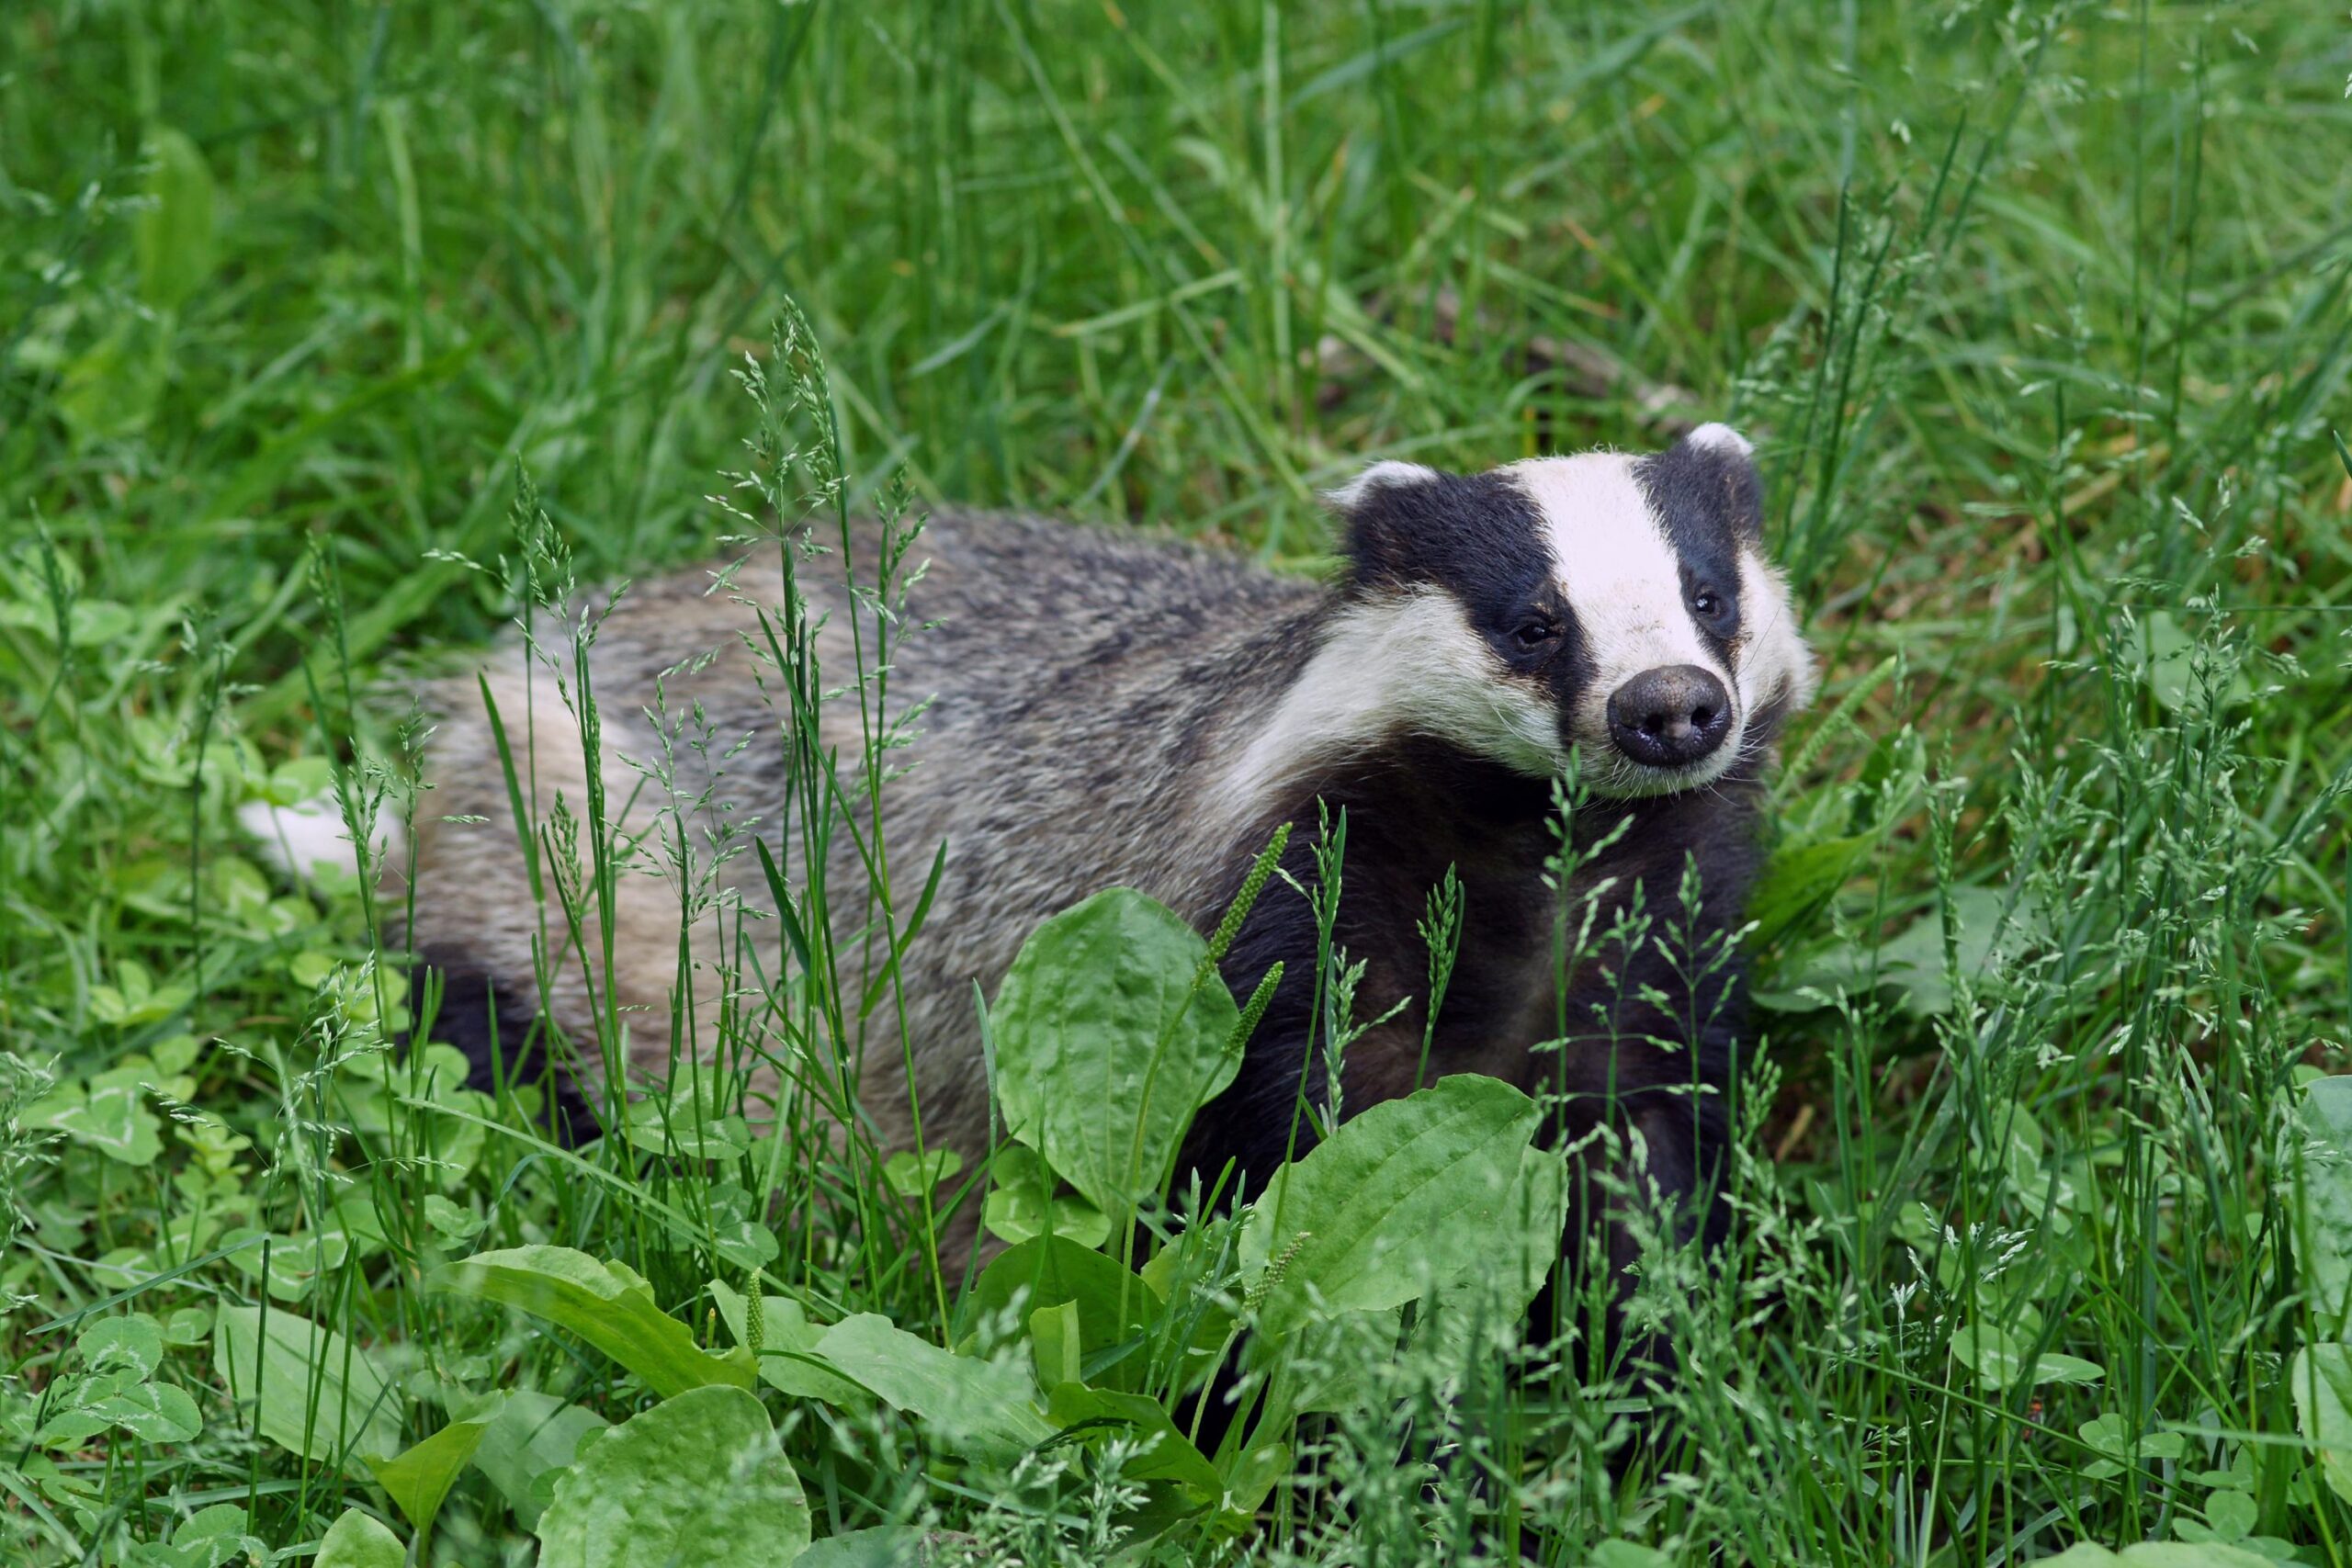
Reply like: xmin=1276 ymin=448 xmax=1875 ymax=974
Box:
xmin=988 ymin=888 xmax=1239 ymax=1213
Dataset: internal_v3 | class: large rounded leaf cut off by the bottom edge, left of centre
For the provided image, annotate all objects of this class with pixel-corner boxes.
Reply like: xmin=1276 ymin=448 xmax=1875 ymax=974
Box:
xmin=538 ymin=1387 xmax=809 ymax=1568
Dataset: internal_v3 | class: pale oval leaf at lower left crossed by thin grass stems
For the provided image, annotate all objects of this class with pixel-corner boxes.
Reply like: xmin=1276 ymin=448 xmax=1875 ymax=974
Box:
xmin=211 ymin=1307 xmax=400 ymax=1474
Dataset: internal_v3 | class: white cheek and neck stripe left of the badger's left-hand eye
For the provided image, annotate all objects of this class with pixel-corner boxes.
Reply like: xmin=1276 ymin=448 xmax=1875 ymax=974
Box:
xmin=1218 ymin=588 xmax=1566 ymax=816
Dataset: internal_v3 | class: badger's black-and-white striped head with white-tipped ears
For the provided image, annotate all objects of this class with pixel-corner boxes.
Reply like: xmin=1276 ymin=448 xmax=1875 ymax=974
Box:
xmin=1284 ymin=425 xmax=1814 ymax=797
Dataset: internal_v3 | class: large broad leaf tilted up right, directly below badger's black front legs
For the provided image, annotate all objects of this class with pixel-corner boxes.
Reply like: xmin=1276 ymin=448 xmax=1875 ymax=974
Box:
xmin=1242 ymin=1075 xmax=1538 ymax=1333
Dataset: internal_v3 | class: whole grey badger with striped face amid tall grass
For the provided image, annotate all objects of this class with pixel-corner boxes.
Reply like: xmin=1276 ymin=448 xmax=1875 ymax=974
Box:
xmin=288 ymin=425 xmax=1811 ymax=1325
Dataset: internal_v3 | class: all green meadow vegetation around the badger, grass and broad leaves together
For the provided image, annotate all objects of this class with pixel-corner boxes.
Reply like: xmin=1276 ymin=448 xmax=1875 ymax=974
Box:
xmin=0 ymin=0 xmax=2352 ymax=1568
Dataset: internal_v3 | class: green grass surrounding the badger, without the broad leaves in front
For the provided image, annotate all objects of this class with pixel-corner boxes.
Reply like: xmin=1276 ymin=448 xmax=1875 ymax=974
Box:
xmin=0 ymin=0 xmax=2352 ymax=1568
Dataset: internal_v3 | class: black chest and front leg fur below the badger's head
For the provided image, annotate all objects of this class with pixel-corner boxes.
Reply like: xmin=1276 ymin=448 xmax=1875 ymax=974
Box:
xmin=1185 ymin=740 xmax=1761 ymax=1335
